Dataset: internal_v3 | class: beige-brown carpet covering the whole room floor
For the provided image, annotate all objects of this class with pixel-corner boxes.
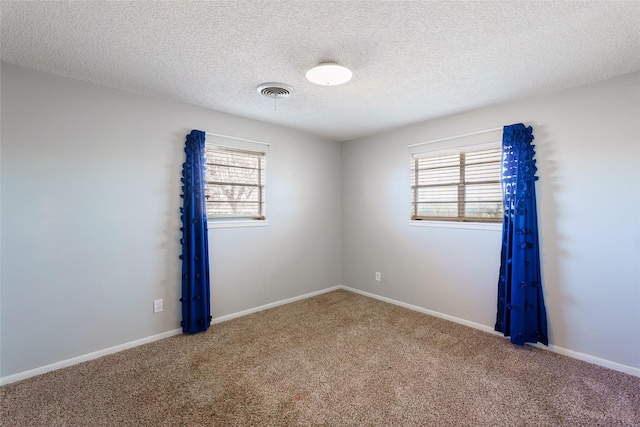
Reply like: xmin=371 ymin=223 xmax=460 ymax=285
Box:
xmin=0 ymin=291 xmax=640 ymax=427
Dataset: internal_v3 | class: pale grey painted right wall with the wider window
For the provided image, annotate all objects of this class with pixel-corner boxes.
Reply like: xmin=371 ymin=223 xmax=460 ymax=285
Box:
xmin=342 ymin=73 xmax=640 ymax=369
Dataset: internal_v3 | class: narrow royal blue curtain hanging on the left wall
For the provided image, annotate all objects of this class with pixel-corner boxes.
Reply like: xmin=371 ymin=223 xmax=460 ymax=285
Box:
xmin=180 ymin=130 xmax=211 ymax=334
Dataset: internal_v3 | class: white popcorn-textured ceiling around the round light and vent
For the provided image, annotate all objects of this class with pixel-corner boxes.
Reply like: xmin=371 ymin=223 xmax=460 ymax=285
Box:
xmin=0 ymin=0 xmax=640 ymax=141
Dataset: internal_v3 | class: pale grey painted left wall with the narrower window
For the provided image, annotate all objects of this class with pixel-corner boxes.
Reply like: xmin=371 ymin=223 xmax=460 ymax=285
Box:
xmin=0 ymin=63 xmax=341 ymax=377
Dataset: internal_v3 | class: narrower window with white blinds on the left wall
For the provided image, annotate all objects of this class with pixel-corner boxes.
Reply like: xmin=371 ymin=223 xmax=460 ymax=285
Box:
xmin=205 ymin=145 xmax=265 ymax=220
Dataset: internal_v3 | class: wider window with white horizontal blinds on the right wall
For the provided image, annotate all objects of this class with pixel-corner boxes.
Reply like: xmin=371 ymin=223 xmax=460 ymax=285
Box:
xmin=411 ymin=147 xmax=503 ymax=222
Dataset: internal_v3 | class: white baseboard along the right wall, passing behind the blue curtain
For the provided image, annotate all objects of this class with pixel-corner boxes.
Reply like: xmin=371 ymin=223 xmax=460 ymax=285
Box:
xmin=340 ymin=286 xmax=640 ymax=378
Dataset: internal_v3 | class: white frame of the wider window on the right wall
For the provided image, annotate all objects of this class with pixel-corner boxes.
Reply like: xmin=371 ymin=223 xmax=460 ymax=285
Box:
xmin=409 ymin=141 xmax=504 ymax=226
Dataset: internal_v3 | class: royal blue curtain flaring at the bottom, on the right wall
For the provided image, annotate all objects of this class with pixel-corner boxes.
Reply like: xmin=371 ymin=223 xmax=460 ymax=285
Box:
xmin=495 ymin=123 xmax=549 ymax=345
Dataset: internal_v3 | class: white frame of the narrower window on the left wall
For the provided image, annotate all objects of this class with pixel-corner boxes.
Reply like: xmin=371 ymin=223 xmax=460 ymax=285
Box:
xmin=205 ymin=142 xmax=268 ymax=224
